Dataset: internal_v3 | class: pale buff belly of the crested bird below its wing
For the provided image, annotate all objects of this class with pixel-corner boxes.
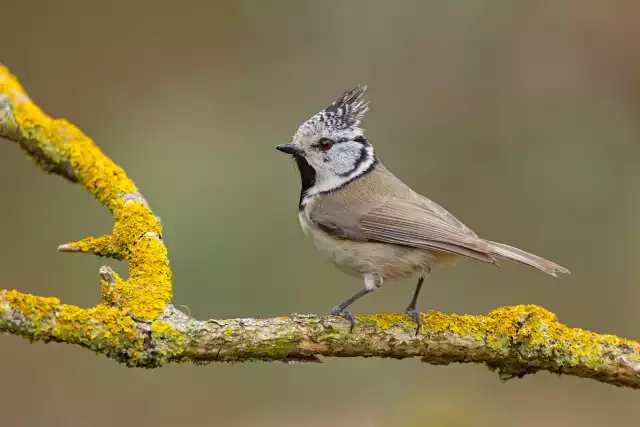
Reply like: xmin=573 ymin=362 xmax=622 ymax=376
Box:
xmin=300 ymin=214 xmax=440 ymax=280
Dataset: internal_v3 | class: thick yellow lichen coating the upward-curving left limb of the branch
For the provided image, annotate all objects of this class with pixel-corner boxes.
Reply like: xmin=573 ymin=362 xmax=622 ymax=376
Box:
xmin=0 ymin=66 xmax=172 ymax=320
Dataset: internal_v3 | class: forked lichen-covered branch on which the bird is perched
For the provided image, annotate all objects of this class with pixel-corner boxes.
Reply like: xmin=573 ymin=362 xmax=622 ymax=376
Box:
xmin=0 ymin=66 xmax=640 ymax=388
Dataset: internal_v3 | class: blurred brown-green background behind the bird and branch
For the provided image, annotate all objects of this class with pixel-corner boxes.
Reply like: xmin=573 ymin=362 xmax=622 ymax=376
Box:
xmin=0 ymin=0 xmax=640 ymax=427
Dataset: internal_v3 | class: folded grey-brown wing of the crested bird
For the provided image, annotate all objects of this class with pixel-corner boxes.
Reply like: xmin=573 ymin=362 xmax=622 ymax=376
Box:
xmin=310 ymin=198 xmax=495 ymax=263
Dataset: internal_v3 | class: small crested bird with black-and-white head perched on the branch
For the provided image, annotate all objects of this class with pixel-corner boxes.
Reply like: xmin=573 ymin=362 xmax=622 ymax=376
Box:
xmin=276 ymin=84 xmax=570 ymax=334
